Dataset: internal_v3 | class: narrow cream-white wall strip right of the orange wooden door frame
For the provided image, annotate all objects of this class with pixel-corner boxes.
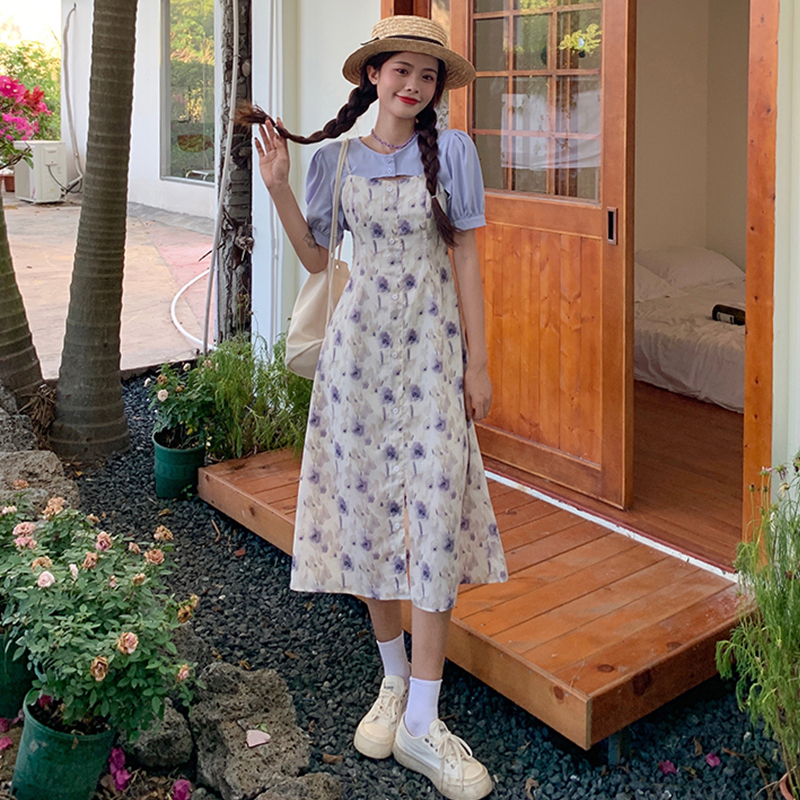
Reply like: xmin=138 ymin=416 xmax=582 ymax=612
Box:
xmin=764 ymin=0 xmax=800 ymax=466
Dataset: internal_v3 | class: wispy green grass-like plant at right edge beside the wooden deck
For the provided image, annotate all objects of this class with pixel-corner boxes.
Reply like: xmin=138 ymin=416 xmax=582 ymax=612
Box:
xmin=717 ymin=454 xmax=800 ymax=800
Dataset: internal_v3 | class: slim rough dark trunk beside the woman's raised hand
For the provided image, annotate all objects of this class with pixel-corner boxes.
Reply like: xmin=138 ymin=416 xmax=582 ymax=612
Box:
xmin=217 ymin=0 xmax=253 ymax=341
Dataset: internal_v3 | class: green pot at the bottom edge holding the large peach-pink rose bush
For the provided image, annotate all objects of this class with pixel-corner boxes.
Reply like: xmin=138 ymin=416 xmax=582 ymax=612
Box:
xmin=11 ymin=706 xmax=115 ymax=800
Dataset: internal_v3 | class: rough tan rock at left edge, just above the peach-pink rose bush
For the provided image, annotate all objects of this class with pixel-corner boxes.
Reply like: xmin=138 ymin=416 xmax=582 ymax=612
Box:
xmin=0 ymin=450 xmax=80 ymax=513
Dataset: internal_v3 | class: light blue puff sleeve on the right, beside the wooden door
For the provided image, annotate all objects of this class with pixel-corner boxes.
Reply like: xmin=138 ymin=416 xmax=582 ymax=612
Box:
xmin=439 ymin=130 xmax=486 ymax=230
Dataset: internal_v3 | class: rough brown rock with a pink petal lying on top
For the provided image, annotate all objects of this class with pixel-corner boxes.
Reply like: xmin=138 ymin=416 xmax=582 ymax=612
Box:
xmin=189 ymin=662 xmax=318 ymax=800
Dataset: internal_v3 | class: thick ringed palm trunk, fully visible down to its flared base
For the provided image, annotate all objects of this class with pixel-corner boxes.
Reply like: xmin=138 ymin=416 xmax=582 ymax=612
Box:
xmin=51 ymin=0 xmax=136 ymax=460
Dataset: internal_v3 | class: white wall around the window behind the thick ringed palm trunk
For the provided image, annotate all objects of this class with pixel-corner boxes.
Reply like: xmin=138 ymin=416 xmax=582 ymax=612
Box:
xmin=62 ymin=0 xmax=215 ymax=217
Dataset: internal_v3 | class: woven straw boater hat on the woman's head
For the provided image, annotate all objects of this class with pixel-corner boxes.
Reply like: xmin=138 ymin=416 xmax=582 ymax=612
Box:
xmin=342 ymin=14 xmax=475 ymax=89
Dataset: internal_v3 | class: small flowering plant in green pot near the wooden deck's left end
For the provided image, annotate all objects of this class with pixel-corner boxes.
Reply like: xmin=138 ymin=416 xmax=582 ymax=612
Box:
xmin=145 ymin=359 xmax=212 ymax=498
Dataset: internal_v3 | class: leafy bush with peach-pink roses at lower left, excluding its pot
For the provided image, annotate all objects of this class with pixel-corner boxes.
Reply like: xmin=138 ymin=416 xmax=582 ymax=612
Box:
xmin=0 ymin=504 xmax=197 ymax=740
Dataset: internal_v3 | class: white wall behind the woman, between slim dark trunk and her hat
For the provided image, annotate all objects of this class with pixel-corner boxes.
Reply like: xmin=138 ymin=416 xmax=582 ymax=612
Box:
xmin=253 ymin=0 xmax=380 ymax=339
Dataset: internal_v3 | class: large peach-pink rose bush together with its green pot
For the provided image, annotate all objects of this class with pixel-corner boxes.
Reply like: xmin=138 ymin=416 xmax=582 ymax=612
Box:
xmin=0 ymin=501 xmax=197 ymax=800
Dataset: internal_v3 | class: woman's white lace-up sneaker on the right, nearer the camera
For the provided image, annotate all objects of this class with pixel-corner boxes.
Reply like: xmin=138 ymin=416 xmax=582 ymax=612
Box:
xmin=392 ymin=719 xmax=492 ymax=800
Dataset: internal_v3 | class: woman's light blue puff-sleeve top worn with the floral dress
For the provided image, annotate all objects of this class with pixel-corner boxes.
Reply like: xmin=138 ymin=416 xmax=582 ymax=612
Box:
xmin=306 ymin=130 xmax=486 ymax=248
